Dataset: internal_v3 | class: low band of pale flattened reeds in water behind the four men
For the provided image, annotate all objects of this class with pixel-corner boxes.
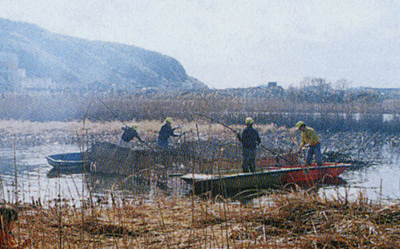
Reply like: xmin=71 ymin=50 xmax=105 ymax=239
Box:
xmin=0 ymin=119 xmax=390 ymax=166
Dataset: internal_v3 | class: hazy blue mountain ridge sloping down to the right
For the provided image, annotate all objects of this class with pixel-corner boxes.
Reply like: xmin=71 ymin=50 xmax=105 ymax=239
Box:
xmin=0 ymin=18 xmax=207 ymax=89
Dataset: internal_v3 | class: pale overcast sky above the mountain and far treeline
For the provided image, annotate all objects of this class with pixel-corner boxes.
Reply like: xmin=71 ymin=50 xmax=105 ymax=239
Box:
xmin=0 ymin=0 xmax=400 ymax=89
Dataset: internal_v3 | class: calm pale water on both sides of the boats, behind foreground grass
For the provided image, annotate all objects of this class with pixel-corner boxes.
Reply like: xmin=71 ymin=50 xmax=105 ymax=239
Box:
xmin=0 ymin=144 xmax=400 ymax=205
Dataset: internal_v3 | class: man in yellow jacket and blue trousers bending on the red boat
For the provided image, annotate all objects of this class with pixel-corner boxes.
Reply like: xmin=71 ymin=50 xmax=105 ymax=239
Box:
xmin=296 ymin=121 xmax=322 ymax=166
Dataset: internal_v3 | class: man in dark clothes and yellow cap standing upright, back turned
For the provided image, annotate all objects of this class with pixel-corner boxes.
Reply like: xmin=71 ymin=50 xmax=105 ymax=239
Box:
xmin=237 ymin=117 xmax=261 ymax=173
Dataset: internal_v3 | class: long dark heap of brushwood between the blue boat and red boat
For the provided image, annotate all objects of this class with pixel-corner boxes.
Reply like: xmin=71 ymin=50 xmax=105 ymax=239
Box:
xmin=87 ymin=139 xmax=298 ymax=176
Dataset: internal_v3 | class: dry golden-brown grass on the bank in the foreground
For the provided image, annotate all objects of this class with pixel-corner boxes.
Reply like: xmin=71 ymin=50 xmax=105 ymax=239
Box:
xmin=8 ymin=192 xmax=400 ymax=248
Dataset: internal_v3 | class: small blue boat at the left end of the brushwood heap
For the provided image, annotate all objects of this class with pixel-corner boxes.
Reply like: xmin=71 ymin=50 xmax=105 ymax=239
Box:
xmin=46 ymin=152 xmax=91 ymax=173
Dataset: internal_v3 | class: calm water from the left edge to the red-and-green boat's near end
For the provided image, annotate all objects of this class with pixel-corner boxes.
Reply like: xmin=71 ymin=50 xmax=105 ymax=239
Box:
xmin=0 ymin=145 xmax=188 ymax=206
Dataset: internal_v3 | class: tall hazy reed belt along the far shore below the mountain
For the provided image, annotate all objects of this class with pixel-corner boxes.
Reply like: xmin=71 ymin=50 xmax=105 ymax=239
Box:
xmin=0 ymin=91 xmax=400 ymax=133
